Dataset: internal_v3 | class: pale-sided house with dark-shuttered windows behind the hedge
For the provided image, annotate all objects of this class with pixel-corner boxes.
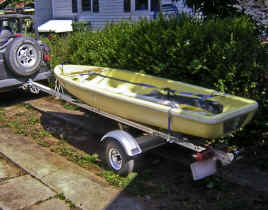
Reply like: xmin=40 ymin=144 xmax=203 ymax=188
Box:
xmin=35 ymin=0 xmax=192 ymax=29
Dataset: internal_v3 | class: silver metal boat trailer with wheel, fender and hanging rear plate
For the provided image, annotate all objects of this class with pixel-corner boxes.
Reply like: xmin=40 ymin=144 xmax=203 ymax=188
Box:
xmin=21 ymin=80 xmax=237 ymax=180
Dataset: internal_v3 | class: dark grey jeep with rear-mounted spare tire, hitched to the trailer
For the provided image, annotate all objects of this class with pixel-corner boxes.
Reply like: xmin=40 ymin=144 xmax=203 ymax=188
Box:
xmin=0 ymin=14 xmax=51 ymax=92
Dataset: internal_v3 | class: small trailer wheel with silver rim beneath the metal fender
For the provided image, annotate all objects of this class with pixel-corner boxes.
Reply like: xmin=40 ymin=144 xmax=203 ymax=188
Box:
xmin=105 ymin=140 xmax=134 ymax=176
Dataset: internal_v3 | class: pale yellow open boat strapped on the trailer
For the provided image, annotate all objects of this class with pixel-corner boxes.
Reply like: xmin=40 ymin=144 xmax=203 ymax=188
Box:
xmin=54 ymin=65 xmax=258 ymax=138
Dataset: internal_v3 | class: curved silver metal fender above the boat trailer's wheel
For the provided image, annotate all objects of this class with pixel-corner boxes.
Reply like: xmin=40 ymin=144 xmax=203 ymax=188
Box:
xmin=100 ymin=130 xmax=142 ymax=157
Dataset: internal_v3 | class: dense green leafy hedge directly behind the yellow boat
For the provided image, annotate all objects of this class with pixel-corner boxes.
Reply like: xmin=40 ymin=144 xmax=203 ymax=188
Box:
xmin=47 ymin=15 xmax=268 ymax=144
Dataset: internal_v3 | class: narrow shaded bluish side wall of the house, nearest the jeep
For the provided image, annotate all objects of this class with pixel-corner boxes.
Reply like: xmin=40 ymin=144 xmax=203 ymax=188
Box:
xmin=35 ymin=0 xmax=52 ymax=26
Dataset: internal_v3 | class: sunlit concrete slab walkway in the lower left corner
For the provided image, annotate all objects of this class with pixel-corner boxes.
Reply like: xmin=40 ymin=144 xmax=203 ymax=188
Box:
xmin=0 ymin=128 xmax=150 ymax=210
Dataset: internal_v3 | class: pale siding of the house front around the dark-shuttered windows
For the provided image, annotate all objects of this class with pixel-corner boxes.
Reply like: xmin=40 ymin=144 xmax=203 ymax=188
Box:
xmin=38 ymin=0 xmax=153 ymax=28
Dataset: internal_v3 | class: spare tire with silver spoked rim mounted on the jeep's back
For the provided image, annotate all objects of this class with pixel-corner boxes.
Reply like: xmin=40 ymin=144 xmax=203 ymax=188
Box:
xmin=5 ymin=36 xmax=42 ymax=77
